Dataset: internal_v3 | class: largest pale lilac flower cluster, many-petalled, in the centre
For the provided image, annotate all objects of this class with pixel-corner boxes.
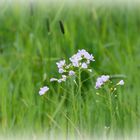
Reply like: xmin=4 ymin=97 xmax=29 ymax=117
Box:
xmin=50 ymin=49 xmax=95 ymax=83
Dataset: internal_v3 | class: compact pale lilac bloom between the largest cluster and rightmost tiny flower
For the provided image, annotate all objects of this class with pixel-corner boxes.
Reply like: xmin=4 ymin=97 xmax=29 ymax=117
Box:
xmin=95 ymin=75 xmax=110 ymax=89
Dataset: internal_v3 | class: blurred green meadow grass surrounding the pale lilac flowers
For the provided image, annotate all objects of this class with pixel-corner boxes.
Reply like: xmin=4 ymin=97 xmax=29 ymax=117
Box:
xmin=0 ymin=4 xmax=140 ymax=135
